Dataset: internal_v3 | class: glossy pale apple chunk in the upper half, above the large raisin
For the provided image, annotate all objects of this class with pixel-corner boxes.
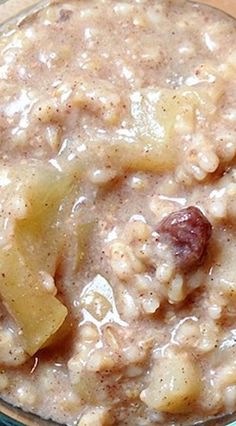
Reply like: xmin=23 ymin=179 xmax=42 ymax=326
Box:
xmin=110 ymin=89 xmax=177 ymax=172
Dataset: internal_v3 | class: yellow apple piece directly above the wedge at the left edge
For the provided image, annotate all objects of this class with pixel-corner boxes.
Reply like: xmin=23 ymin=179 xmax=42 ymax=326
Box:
xmin=15 ymin=167 xmax=72 ymax=275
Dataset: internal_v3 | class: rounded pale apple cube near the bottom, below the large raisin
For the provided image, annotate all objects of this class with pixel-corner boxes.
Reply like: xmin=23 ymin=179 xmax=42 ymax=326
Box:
xmin=140 ymin=353 xmax=201 ymax=413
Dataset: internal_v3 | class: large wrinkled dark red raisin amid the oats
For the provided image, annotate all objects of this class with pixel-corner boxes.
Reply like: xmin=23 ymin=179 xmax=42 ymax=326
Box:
xmin=157 ymin=206 xmax=212 ymax=270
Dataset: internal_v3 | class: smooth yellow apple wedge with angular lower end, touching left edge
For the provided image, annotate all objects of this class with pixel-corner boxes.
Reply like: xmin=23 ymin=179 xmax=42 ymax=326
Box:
xmin=0 ymin=246 xmax=67 ymax=355
